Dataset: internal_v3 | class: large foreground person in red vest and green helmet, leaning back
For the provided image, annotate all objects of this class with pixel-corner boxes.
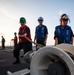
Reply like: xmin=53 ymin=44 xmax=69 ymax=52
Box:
xmin=13 ymin=17 xmax=32 ymax=64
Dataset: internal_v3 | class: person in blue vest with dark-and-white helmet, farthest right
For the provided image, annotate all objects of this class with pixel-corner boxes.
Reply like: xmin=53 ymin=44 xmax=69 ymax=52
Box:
xmin=54 ymin=14 xmax=73 ymax=45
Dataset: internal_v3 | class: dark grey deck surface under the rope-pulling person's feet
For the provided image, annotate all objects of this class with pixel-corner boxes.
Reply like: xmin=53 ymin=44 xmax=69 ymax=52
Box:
xmin=0 ymin=48 xmax=30 ymax=75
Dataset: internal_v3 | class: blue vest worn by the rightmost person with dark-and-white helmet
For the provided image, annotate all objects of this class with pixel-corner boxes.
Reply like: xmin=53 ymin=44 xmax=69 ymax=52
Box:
xmin=56 ymin=25 xmax=71 ymax=44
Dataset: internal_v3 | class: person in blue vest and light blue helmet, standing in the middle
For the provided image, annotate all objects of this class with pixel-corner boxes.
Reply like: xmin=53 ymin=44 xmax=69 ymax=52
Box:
xmin=34 ymin=17 xmax=48 ymax=50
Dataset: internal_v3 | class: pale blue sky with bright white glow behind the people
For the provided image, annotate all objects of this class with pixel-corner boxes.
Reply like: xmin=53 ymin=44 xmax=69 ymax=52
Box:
xmin=0 ymin=0 xmax=74 ymax=45
